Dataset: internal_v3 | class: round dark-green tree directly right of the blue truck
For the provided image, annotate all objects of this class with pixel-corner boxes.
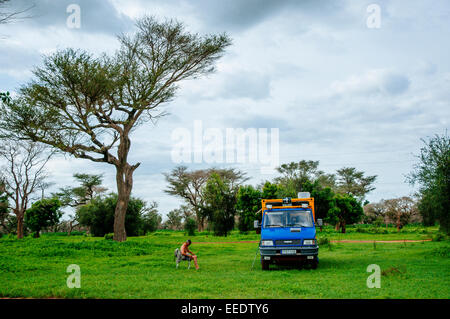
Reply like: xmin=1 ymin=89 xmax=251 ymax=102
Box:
xmin=327 ymin=194 xmax=364 ymax=233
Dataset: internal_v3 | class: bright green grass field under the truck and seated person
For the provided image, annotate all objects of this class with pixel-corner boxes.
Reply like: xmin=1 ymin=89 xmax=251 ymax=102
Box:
xmin=0 ymin=228 xmax=450 ymax=299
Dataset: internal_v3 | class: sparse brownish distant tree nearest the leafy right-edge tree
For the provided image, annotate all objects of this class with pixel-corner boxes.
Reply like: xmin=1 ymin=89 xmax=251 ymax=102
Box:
xmin=384 ymin=196 xmax=418 ymax=231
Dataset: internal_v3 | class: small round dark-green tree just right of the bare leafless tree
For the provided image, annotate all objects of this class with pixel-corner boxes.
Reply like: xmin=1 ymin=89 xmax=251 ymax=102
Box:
xmin=25 ymin=198 xmax=62 ymax=237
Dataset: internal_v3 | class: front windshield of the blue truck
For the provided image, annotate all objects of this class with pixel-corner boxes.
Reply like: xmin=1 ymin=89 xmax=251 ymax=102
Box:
xmin=264 ymin=210 xmax=313 ymax=228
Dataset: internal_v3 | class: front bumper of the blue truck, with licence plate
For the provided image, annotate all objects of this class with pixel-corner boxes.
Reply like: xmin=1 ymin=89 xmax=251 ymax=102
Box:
xmin=259 ymin=245 xmax=319 ymax=261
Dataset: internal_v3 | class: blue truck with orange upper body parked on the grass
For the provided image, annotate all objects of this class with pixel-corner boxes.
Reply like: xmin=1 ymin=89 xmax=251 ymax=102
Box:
xmin=254 ymin=192 xmax=322 ymax=270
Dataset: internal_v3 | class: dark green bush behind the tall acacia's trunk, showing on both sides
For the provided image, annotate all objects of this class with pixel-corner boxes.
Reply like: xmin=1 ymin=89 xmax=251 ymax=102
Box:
xmin=77 ymin=194 xmax=160 ymax=237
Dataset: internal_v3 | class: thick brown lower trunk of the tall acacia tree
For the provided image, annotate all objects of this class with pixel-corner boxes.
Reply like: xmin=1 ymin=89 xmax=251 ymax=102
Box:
xmin=113 ymin=164 xmax=133 ymax=242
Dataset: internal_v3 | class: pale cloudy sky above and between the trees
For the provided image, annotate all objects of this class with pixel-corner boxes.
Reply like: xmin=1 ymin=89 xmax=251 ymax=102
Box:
xmin=0 ymin=0 xmax=450 ymax=220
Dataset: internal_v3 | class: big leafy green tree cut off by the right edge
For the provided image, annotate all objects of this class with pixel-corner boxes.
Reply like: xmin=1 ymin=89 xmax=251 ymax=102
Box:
xmin=408 ymin=132 xmax=450 ymax=234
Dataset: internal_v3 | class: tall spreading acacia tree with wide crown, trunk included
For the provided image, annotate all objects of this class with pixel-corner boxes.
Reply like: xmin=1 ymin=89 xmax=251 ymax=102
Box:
xmin=0 ymin=17 xmax=231 ymax=241
